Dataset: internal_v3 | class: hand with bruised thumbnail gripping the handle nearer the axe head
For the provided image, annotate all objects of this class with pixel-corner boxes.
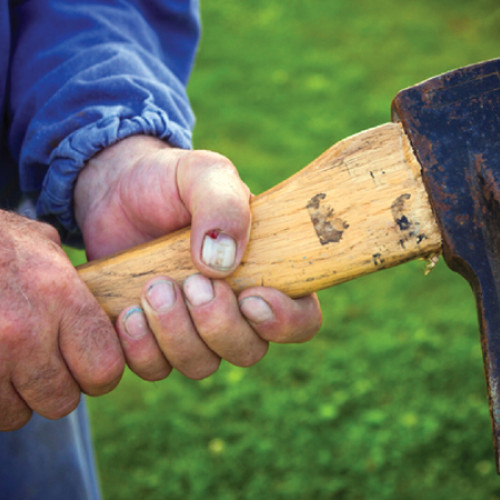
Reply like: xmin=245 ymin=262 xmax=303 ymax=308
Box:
xmin=75 ymin=136 xmax=321 ymax=380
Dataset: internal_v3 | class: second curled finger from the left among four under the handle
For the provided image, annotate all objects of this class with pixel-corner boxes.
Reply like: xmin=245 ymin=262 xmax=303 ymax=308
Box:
xmin=142 ymin=277 xmax=220 ymax=380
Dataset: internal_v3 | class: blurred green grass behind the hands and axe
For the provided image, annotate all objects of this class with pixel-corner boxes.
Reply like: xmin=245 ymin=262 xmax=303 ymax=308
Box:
xmin=79 ymin=0 xmax=500 ymax=500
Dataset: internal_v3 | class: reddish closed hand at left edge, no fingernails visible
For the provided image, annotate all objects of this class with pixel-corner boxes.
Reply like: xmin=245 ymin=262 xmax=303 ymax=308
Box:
xmin=0 ymin=211 xmax=124 ymax=431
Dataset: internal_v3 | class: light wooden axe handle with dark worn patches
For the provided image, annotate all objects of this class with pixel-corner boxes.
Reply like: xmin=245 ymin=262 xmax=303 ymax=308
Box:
xmin=78 ymin=123 xmax=441 ymax=319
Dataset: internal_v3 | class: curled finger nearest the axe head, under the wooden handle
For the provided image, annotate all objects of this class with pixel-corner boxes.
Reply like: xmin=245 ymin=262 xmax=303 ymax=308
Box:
xmin=239 ymin=287 xmax=322 ymax=343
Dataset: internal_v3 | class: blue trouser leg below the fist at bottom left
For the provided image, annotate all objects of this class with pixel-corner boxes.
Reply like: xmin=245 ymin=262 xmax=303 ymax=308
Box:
xmin=0 ymin=399 xmax=101 ymax=500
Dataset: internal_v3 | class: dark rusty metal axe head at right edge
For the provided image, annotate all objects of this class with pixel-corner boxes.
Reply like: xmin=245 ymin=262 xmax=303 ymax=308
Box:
xmin=392 ymin=59 xmax=500 ymax=473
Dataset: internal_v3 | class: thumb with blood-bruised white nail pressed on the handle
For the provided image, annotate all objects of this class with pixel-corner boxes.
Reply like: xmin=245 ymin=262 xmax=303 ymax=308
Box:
xmin=177 ymin=151 xmax=251 ymax=278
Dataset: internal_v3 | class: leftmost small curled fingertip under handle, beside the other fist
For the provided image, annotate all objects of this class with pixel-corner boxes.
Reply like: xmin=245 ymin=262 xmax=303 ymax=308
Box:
xmin=116 ymin=305 xmax=172 ymax=381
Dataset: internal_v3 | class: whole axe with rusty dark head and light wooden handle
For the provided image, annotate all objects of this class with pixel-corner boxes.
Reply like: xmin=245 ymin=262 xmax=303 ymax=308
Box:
xmin=78 ymin=59 xmax=500 ymax=471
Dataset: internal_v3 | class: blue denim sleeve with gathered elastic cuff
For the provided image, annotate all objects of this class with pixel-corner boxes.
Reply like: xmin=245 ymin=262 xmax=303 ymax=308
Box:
xmin=9 ymin=0 xmax=199 ymax=238
